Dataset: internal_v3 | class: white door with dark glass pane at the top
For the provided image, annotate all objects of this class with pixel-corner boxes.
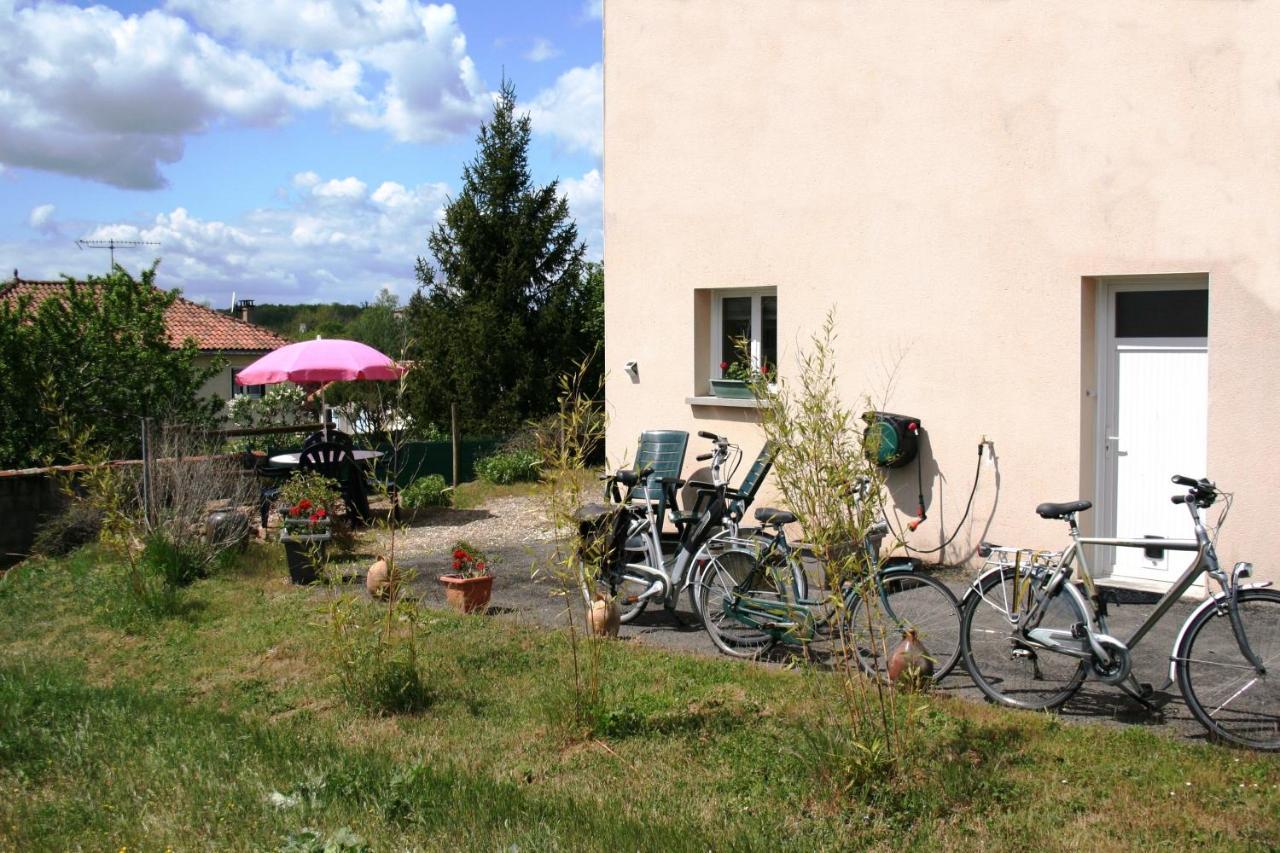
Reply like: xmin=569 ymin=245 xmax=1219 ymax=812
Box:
xmin=1101 ymin=277 xmax=1208 ymax=583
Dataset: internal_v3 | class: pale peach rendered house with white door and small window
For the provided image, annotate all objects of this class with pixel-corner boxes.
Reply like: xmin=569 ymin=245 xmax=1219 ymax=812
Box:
xmin=604 ymin=0 xmax=1280 ymax=589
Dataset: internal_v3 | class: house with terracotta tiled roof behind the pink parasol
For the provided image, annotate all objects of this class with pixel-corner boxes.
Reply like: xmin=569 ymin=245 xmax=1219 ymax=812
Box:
xmin=0 ymin=275 xmax=289 ymax=400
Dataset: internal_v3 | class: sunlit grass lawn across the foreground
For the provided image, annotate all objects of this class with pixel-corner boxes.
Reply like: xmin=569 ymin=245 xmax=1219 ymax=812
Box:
xmin=0 ymin=547 xmax=1280 ymax=850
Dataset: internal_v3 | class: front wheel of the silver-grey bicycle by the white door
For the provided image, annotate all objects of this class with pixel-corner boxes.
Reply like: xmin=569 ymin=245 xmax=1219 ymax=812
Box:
xmin=1175 ymin=589 xmax=1280 ymax=751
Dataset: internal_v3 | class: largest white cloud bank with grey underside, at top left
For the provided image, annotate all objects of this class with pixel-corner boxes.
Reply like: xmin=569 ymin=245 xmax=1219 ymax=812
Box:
xmin=0 ymin=0 xmax=493 ymax=190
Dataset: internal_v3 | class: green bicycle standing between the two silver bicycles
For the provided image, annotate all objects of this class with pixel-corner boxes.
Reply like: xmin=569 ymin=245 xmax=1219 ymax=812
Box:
xmin=695 ymin=482 xmax=960 ymax=681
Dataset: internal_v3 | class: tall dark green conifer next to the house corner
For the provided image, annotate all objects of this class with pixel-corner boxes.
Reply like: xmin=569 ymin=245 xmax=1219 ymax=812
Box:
xmin=408 ymin=82 xmax=603 ymax=433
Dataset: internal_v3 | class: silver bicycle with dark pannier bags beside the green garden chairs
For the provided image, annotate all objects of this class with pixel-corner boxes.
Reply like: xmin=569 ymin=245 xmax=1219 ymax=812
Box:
xmin=596 ymin=432 xmax=808 ymax=624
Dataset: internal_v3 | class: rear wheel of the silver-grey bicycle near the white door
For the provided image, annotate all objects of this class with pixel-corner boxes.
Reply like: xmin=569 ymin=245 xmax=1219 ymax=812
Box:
xmin=960 ymin=567 xmax=1088 ymax=711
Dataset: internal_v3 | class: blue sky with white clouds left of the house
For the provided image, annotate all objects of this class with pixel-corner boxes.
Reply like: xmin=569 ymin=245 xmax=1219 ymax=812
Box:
xmin=0 ymin=0 xmax=603 ymax=307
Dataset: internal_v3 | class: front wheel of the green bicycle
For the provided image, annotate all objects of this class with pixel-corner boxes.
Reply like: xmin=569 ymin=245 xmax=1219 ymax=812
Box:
xmin=845 ymin=573 xmax=960 ymax=681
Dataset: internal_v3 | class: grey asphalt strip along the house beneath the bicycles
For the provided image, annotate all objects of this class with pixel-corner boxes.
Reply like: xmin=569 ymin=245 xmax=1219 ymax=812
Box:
xmin=363 ymin=543 xmax=1228 ymax=742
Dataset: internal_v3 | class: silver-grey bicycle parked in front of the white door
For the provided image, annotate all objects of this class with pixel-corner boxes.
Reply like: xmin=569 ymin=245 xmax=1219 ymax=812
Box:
xmin=961 ymin=476 xmax=1280 ymax=751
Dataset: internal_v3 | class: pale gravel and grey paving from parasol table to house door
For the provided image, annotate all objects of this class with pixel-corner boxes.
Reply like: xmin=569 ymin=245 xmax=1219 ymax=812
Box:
xmin=348 ymin=498 xmax=1204 ymax=740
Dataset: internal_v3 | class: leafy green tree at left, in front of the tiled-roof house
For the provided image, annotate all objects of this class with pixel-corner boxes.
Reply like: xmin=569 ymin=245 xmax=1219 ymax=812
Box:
xmin=0 ymin=266 xmax=221 ymax=467
